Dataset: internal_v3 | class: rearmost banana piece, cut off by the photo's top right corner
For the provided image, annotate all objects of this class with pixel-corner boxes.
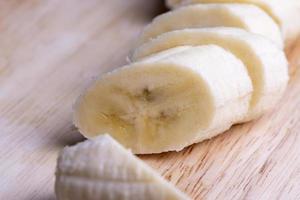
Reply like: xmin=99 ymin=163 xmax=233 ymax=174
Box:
xmin=169 ymin=0 xmax=300 ymax=43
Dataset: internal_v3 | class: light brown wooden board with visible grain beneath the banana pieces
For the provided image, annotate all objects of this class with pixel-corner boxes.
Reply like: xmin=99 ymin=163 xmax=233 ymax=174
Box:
xmin=0 ymin=0 xmax=300 ymax=200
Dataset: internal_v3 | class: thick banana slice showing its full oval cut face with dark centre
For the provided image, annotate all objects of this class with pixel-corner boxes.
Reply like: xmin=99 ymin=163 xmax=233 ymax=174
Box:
xmin=74 ymin=45 xmax=252 ymax=154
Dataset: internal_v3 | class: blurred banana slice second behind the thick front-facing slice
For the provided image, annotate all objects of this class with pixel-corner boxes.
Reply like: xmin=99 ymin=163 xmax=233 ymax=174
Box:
xmin=139 ymin=4 xmax=284 ymax=48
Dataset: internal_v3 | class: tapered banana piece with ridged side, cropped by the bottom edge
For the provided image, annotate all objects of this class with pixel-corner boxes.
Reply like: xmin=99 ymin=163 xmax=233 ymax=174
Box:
xmin=55 ymin=135 xmax=189 ymax=200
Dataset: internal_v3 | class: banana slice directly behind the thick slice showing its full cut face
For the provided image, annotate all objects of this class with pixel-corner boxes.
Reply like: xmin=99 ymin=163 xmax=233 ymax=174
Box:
xmin=132 ymin=28 xmax=288 ymax=122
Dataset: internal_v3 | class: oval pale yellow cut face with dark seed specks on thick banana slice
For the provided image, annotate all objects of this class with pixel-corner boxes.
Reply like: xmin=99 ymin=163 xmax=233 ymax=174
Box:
xmin=77 ymin=65 xmax=212 ymax=152
